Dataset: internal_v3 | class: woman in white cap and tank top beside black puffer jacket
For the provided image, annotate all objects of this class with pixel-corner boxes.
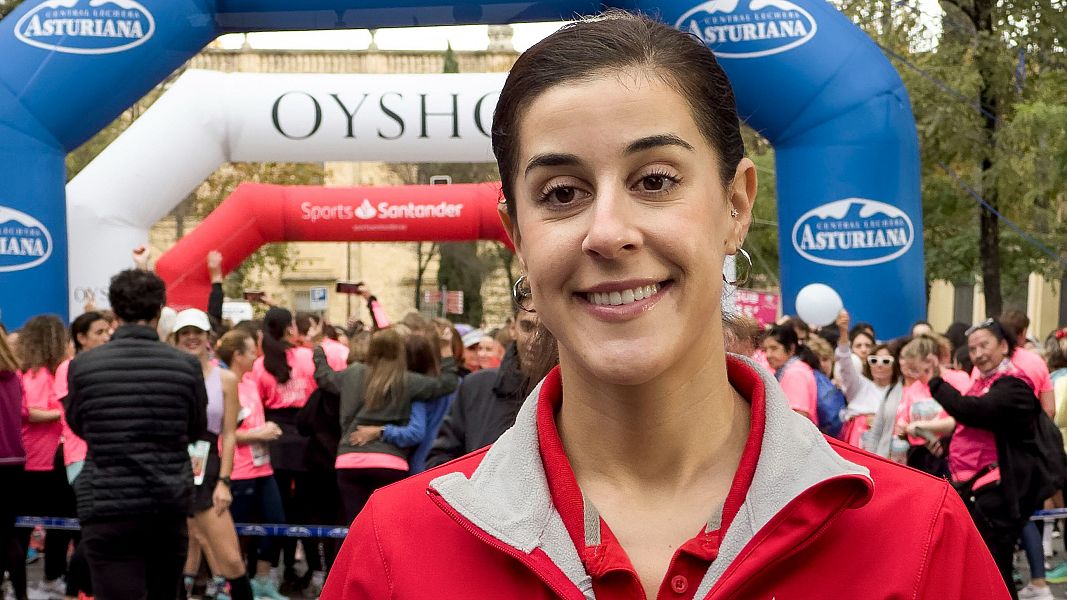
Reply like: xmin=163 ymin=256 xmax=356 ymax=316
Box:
xmin=174 ymin=309 xmax=253 ymax=600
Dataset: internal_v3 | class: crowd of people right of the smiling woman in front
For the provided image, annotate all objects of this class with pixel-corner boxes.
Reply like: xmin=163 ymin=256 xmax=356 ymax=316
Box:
xmin=728 ymin=310 xmax=1067 ymax=599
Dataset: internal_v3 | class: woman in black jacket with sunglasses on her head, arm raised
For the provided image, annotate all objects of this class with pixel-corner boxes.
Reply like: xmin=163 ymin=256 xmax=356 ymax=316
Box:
xmin=907 ymin=319 xmax=1045 ymax=597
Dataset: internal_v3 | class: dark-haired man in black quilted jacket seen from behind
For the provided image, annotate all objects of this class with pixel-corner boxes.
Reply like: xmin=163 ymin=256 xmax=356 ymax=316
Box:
xmin=66 ymin=270 xmax=207 ymax=600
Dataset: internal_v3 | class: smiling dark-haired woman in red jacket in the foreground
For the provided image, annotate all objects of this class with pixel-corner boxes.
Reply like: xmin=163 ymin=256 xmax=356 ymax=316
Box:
xmin=322 ymin=13 xmax=1007 ymax=600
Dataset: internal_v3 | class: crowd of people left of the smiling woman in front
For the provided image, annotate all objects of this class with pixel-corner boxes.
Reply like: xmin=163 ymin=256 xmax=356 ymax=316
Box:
xmin=0 ymin=249 xmax=537 ymax=600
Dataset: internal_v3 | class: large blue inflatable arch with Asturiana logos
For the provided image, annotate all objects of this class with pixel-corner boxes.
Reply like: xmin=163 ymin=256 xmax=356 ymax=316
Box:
xmin=0 ymin=0 xmax=925 ymax=337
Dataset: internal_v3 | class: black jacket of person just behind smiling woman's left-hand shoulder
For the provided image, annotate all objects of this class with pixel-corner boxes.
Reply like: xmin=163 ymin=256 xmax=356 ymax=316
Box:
xmin=426 ymin=344 xmax=529 ymax=469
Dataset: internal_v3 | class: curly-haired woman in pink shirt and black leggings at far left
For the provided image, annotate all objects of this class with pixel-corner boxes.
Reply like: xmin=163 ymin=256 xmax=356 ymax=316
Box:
xmin=18 ymin=315 xmax=76 ymax=595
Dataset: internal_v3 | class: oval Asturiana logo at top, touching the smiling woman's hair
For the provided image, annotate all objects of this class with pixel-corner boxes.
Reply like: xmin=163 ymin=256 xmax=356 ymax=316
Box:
xmin=674 ymin=0 xmax=818 ymax=59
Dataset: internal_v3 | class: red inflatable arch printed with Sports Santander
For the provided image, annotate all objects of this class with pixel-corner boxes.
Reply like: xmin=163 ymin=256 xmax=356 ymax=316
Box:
xmin=156 ymin=183 xmax=511 ymax=310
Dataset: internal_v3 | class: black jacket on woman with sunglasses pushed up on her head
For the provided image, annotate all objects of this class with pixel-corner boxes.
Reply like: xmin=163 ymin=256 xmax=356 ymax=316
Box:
xmin=929 ymin=376 xmax=1044 ymax=524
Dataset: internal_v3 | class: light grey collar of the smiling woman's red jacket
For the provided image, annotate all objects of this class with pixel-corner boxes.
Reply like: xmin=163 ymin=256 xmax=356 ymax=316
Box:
xmin=430 ymin=354 xmax=873 ymax=598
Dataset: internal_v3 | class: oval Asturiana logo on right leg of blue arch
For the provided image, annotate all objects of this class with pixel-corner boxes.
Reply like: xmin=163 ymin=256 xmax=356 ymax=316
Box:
xmin=793 ymin=198 xmax=915 ymax=267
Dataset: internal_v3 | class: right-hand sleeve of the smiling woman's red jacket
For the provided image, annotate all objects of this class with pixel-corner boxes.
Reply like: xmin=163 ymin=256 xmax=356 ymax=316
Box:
xmin=914 ymin=485 xmax=1010 ymax=600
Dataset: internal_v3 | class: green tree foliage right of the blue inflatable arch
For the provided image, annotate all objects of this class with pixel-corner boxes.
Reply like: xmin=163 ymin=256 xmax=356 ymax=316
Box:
xmin=835 ymin=0 xmax=1067 ymax=304
